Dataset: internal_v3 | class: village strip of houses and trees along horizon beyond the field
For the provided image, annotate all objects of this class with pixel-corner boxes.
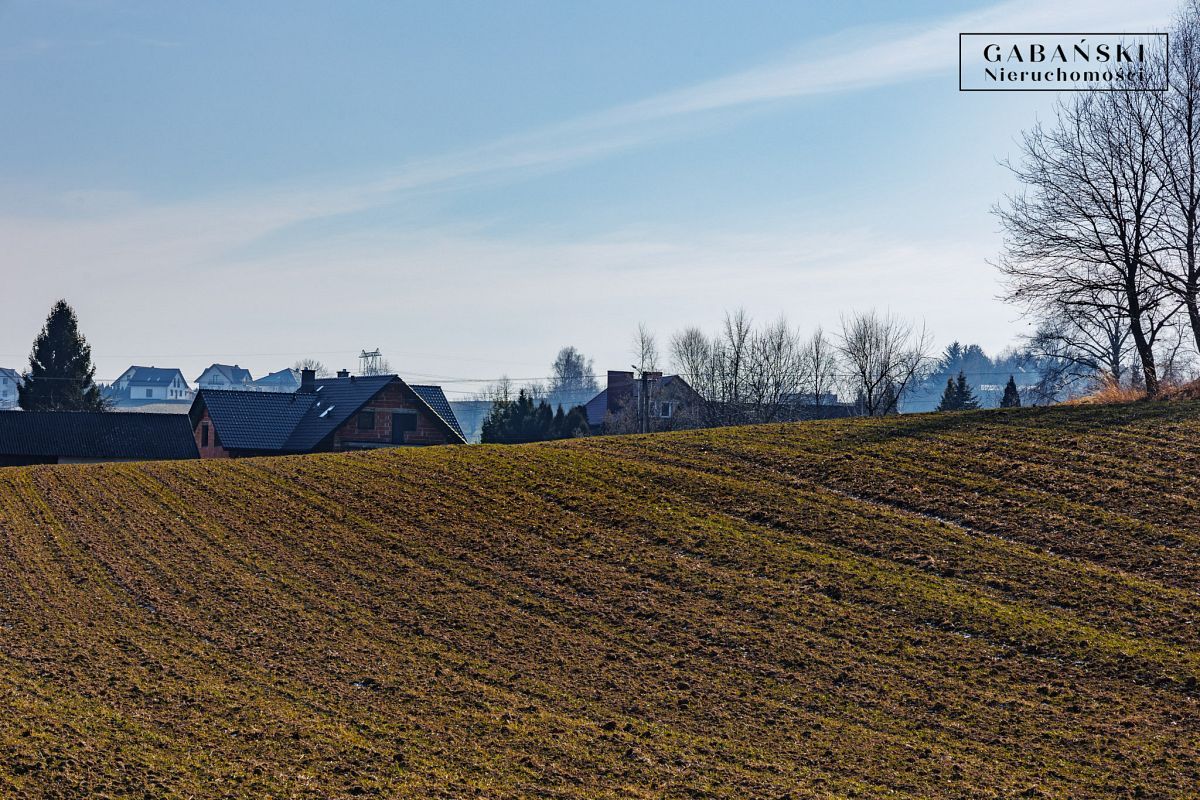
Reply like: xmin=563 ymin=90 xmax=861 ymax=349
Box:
xmin=0 ymin=301 xmax=1051 ymax=467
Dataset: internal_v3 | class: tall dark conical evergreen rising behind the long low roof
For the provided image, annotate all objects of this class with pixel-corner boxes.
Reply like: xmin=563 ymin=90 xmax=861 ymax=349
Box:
xmin=19 ymin=300 xmax=104 ymax=411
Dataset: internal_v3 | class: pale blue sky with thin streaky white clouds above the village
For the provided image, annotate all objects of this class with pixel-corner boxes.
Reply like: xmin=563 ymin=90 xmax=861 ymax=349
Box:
xmin=0 ymin=0 xmax=1176 ymax=399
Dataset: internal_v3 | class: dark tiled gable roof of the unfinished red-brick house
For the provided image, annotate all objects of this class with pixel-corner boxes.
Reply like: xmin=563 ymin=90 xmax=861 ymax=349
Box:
xmin=190 ymin=375 xmax=466 ymax=452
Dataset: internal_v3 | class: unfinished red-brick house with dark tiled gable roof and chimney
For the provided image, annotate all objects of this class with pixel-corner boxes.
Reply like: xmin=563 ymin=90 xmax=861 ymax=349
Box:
xmin=188 ymin=369 xmax=467 ymax=458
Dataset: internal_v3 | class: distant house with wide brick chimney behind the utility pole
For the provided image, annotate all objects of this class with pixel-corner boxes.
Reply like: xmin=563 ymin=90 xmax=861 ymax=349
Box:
xmin=584 ymin=369 xmax=701 ymax=433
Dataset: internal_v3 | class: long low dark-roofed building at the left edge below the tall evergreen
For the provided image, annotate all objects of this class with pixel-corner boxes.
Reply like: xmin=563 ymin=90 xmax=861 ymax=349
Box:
xmin=0 ymin=411 xmax=199 ymax=467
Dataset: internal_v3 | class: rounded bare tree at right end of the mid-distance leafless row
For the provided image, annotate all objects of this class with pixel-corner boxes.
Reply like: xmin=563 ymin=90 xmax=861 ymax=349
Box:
xmin=838 ymin=309 xmax=931 ymax=416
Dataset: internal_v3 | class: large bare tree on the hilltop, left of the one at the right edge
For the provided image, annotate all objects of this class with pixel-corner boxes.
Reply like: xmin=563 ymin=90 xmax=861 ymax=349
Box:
xmin=995 ymin=85 xmax=1171 ymax=396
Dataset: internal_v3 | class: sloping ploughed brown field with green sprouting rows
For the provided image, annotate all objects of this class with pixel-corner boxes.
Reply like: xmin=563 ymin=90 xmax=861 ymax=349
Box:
xmin=0 ymin=403 xmax=1200 ymax=798
